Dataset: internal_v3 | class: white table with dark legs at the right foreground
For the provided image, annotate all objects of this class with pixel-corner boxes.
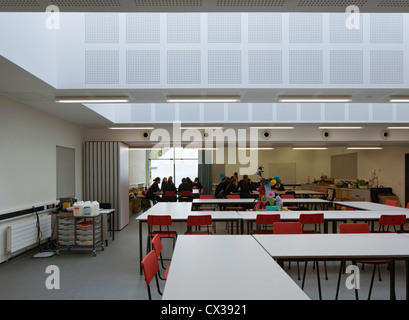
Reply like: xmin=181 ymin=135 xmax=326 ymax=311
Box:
xmin=254 ymin=233 xmax=409 ymax=299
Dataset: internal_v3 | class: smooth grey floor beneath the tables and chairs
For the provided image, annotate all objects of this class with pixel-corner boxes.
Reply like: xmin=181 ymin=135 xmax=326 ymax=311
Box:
xmin=0 ymin=212 xmax=406 ymax=300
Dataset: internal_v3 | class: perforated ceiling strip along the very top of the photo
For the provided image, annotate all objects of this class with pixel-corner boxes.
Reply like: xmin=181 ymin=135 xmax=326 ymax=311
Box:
xmin=0 ymin=0 xmax=409 ymax=12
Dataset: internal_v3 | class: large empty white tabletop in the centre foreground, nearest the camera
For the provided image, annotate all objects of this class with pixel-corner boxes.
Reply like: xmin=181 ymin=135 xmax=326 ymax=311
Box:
xmin=162 ymin=235 xmax=309 ymax=300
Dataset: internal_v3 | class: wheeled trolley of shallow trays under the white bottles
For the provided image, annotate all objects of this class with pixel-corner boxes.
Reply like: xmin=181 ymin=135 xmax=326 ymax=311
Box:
xmin=57 ymin=214 xmax=104 ymax=256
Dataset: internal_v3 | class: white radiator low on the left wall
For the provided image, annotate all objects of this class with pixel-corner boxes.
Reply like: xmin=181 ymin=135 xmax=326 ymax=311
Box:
xmin=6 ymin=214 xmax=51 ymax=255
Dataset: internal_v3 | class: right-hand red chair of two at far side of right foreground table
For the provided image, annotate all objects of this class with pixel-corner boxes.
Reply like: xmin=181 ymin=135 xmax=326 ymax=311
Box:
xmin=335 ymin=223 xmax=395 ymax=300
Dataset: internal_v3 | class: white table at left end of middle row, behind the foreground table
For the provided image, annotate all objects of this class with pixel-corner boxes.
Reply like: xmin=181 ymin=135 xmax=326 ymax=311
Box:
xmin=136 ymin=202 xmax=242 ymax=272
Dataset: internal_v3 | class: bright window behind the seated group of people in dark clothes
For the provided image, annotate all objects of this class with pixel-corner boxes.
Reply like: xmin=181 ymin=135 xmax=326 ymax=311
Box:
xmin=149 ymin=148 xmax=199 ymax=187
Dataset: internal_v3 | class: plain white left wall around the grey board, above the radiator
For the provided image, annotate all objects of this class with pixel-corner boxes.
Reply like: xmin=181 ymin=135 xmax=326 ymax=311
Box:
xmin=0 ymin=96 xmax=83 ymax=213
